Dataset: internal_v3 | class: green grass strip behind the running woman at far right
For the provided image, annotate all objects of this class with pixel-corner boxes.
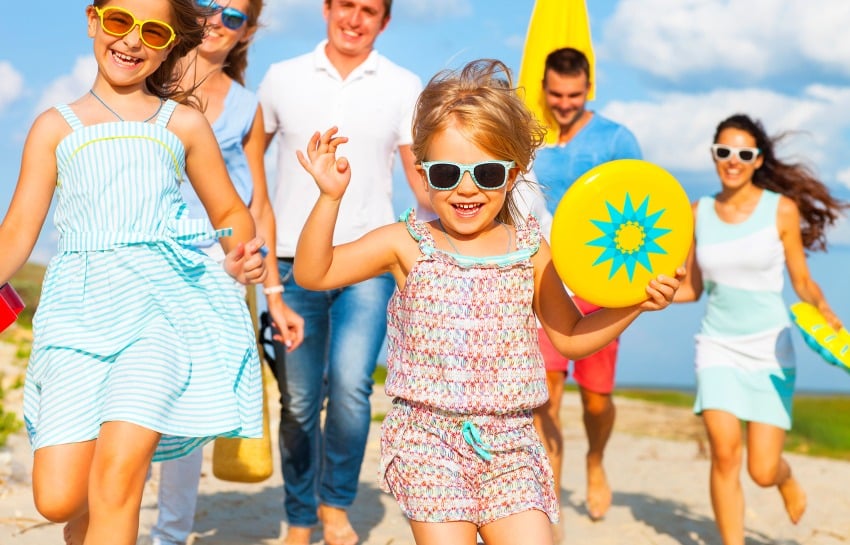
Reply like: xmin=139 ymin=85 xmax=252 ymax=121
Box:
xmin=617 ymin=390 xmax=850 ymax=460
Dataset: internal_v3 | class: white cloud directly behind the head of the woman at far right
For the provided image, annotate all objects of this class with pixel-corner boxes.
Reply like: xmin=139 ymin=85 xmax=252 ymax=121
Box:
xmin=601 ymin=85 xmax=850 ymax=180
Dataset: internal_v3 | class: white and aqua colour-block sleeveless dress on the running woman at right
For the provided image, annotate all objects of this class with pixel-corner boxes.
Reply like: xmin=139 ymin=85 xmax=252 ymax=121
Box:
xmin=694 ymin=190 xmax=796 ymax=429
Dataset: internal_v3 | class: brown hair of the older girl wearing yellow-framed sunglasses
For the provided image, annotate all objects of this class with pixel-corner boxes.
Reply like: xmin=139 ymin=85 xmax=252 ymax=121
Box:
xmin=92 ymin=0 xmax=209 ymax=107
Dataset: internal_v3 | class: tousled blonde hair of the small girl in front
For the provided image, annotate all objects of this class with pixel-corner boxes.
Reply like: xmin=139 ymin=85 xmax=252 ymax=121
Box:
xmin=411 ymin=59 xmax=546 ymax=225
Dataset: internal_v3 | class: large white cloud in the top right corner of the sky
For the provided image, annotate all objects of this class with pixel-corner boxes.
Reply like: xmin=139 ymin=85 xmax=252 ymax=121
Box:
xmin=602 ymin=0 xmax=850 ymax=82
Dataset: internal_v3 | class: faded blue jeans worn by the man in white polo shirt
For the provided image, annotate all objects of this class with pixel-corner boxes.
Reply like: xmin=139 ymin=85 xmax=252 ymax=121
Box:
xmin=273 ymin=260 xmax=395 ymax=527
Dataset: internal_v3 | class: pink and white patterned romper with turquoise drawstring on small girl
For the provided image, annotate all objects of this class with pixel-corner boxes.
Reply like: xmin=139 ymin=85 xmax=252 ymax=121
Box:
xmin=380 ymin=207 xmax=560 ymax=527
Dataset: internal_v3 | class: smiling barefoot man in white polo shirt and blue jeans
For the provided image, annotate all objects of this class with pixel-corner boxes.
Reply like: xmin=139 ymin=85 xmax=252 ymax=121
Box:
xmin=253 ymin=0 xmax=428 ymax=545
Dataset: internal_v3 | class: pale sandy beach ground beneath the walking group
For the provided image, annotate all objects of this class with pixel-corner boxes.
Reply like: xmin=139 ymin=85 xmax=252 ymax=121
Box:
xmin=0 ymin=354 xmax=850 ymax=545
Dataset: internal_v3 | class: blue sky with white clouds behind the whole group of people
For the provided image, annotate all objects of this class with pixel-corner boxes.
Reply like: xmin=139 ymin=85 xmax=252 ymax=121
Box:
xmin=0 ymin=0 xmax=850 ymax=391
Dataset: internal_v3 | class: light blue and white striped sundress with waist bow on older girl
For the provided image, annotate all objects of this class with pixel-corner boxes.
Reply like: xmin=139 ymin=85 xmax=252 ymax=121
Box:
xmin=24 ymin=101 xmax=262 ymax=460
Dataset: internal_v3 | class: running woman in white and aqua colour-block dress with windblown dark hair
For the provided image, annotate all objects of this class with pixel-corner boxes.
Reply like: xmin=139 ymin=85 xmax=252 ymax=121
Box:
xmin=675 ymin=114 xmax=847 ymax=545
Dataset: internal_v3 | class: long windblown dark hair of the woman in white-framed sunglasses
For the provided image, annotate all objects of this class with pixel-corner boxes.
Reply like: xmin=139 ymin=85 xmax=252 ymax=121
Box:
xmin=714 ymin=114 xmax=850 ymax=251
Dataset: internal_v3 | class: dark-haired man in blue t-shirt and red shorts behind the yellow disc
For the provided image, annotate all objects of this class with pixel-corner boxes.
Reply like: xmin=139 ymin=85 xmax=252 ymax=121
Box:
xmin=534 ymin=48 xmax=641 ymax=519
